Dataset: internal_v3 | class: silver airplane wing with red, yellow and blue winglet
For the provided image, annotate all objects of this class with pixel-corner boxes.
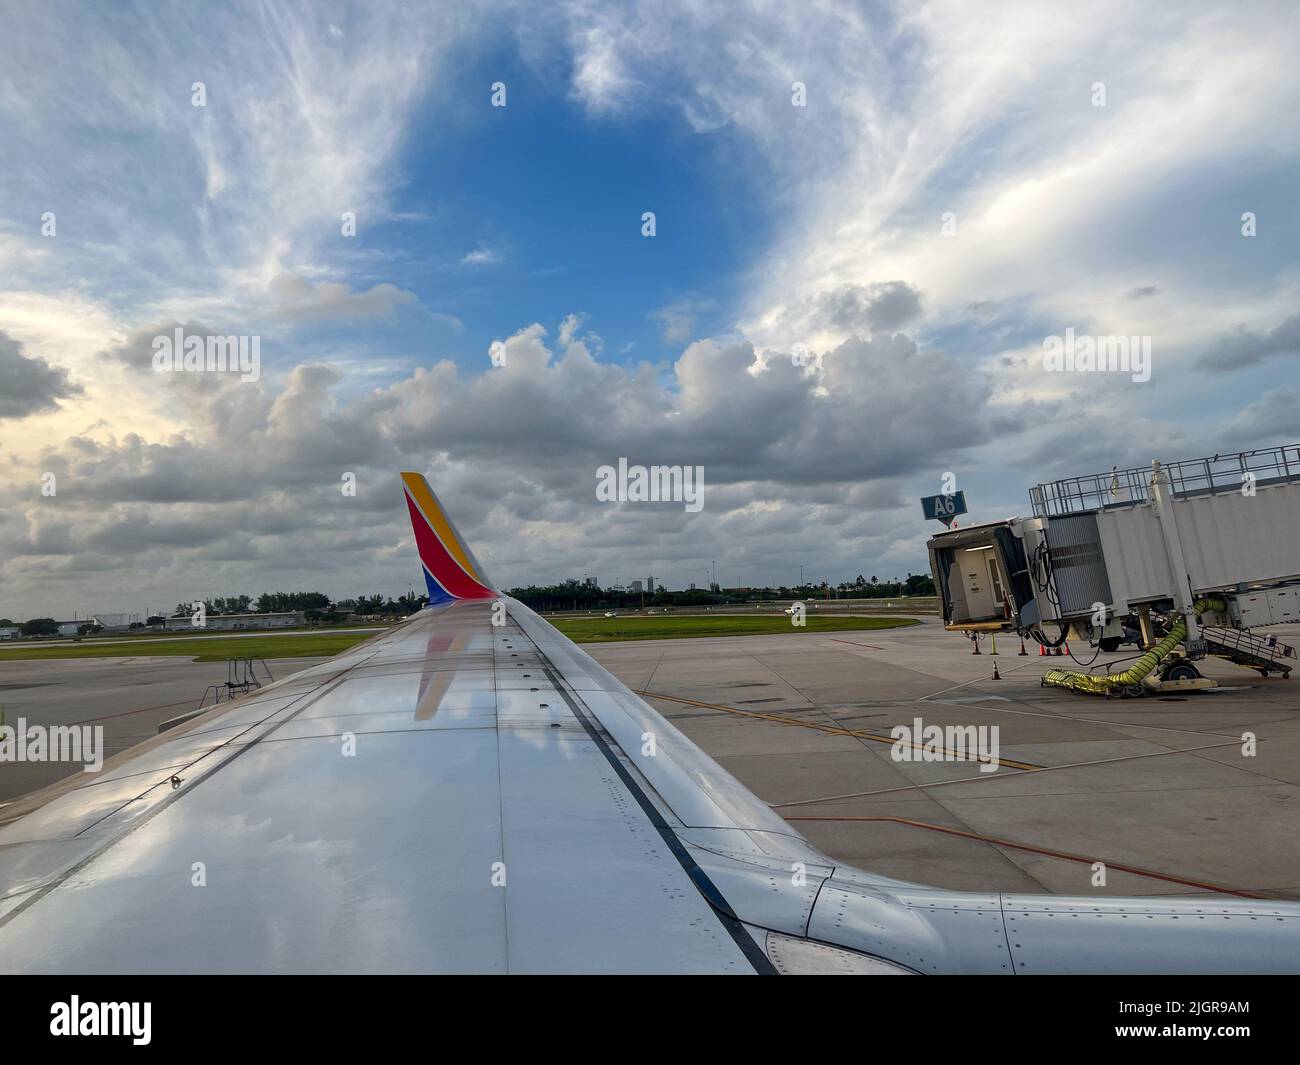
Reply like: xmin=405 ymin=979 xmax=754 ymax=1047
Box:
xmin=0 ymin=473 xmax=1300 ymax=974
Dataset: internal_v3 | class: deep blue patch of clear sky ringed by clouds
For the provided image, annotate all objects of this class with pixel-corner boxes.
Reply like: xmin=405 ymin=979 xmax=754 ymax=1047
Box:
xmin=363 ymin=51 xmax=772 ymax=379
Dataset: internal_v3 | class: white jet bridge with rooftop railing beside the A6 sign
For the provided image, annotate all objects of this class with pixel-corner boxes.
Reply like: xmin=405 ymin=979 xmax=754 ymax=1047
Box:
xmin=927 ymin=445 xmax=1300 ymax=675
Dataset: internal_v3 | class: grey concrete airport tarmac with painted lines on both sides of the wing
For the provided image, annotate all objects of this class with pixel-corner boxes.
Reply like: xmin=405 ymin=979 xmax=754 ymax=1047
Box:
xmin=0 ymin=618 xmax=1300 ymax=899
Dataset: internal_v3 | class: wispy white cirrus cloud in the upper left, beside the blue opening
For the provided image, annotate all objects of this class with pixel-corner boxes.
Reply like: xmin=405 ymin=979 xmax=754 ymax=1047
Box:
xmin=0 ymin=4 xmax=478 ymax=312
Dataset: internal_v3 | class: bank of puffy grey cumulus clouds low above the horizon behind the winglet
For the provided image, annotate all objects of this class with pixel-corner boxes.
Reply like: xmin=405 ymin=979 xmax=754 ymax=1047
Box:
xmin=0 ymin=315 xmax=1008 ymax=611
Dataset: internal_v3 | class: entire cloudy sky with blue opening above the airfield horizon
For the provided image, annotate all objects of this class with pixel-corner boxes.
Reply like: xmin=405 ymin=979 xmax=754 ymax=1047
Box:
xmin=0 ymin=0 xmax=1300 ymax=619
